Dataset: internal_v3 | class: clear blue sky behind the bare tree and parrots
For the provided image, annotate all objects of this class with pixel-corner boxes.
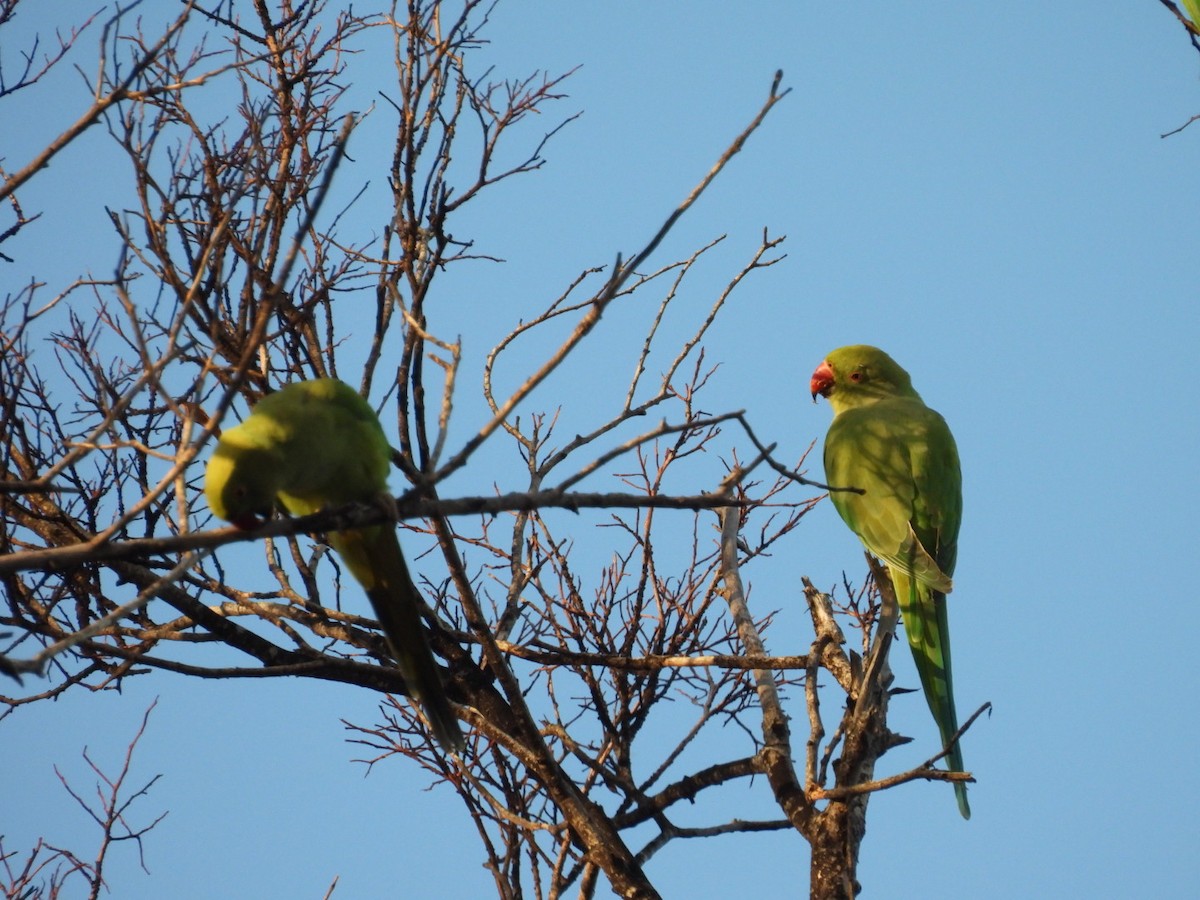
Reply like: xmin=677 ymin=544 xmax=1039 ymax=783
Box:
xmin=0 ymin=0 xmax=1200 ymax=899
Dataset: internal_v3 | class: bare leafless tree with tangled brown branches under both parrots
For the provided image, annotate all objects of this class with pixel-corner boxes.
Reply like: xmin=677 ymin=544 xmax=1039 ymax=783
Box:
xmin=0 ymin=0 xmax=978 ymax=900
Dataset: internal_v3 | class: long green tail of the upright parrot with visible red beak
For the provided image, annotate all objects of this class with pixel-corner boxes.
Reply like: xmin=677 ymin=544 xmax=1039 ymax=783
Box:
xmin=892 ymin=570 xmax=971 ymax=818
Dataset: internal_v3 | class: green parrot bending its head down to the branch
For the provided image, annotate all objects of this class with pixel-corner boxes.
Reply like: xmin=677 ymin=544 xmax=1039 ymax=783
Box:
xmin=204 ymin=378 xmax=464 ymax=752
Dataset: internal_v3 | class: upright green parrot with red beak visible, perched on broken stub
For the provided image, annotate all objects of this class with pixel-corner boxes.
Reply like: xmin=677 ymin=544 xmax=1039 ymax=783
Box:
xmin=810 ymin=344 xmax=971 ymax=818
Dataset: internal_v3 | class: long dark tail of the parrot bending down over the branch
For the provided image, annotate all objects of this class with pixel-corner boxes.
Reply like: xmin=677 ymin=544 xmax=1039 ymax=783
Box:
xmin=338 ymin=526 xmax=467 ymax=752
